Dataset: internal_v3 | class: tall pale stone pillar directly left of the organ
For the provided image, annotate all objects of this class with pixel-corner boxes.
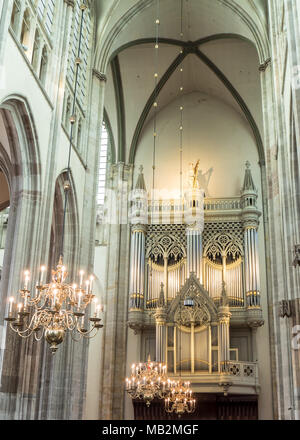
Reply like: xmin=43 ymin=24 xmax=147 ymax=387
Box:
xmin=99 ymin=163 xmax=132 ymax=420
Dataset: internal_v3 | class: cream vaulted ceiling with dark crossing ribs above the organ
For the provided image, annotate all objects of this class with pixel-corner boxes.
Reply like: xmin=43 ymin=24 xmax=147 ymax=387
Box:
xmin=98 ymin=0 xmax=266 ymax=162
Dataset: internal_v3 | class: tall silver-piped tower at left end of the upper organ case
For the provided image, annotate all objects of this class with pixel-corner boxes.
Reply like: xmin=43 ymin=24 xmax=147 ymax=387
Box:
xmin=129 ymin=225 xmax=147 ymax=311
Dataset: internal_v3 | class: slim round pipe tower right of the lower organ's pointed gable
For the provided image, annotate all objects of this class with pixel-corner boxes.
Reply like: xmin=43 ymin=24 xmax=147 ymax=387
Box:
xmin=218 ymin=306 xmax=231 ymax=372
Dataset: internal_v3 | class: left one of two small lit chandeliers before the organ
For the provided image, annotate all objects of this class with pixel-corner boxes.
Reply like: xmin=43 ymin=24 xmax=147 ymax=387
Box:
xmin=126 ymin=356 xmax=170 ymax=407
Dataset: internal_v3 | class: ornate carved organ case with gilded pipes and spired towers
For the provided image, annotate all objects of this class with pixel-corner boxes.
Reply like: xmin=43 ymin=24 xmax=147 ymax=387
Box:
xmin=129 ymin=164 xmax=263 ymax=394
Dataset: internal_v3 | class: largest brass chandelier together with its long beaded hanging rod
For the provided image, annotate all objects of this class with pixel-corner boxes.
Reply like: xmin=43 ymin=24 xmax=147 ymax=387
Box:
xmin=5 ymin=2 xmax=103 ymax=354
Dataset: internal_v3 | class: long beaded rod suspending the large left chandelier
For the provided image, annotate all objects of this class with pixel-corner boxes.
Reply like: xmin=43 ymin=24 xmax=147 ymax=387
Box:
xmin=60 ymin=1 xmax=87 ymax=257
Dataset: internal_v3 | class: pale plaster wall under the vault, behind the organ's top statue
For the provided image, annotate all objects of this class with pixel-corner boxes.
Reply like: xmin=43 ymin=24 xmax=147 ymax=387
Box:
xmin=135 ymin=92 xmax=260 ymax=203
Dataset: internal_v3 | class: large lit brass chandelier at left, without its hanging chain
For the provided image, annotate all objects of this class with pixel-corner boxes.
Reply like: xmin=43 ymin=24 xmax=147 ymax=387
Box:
xmin=5 ymin=259 xmax=103 ymax=353
